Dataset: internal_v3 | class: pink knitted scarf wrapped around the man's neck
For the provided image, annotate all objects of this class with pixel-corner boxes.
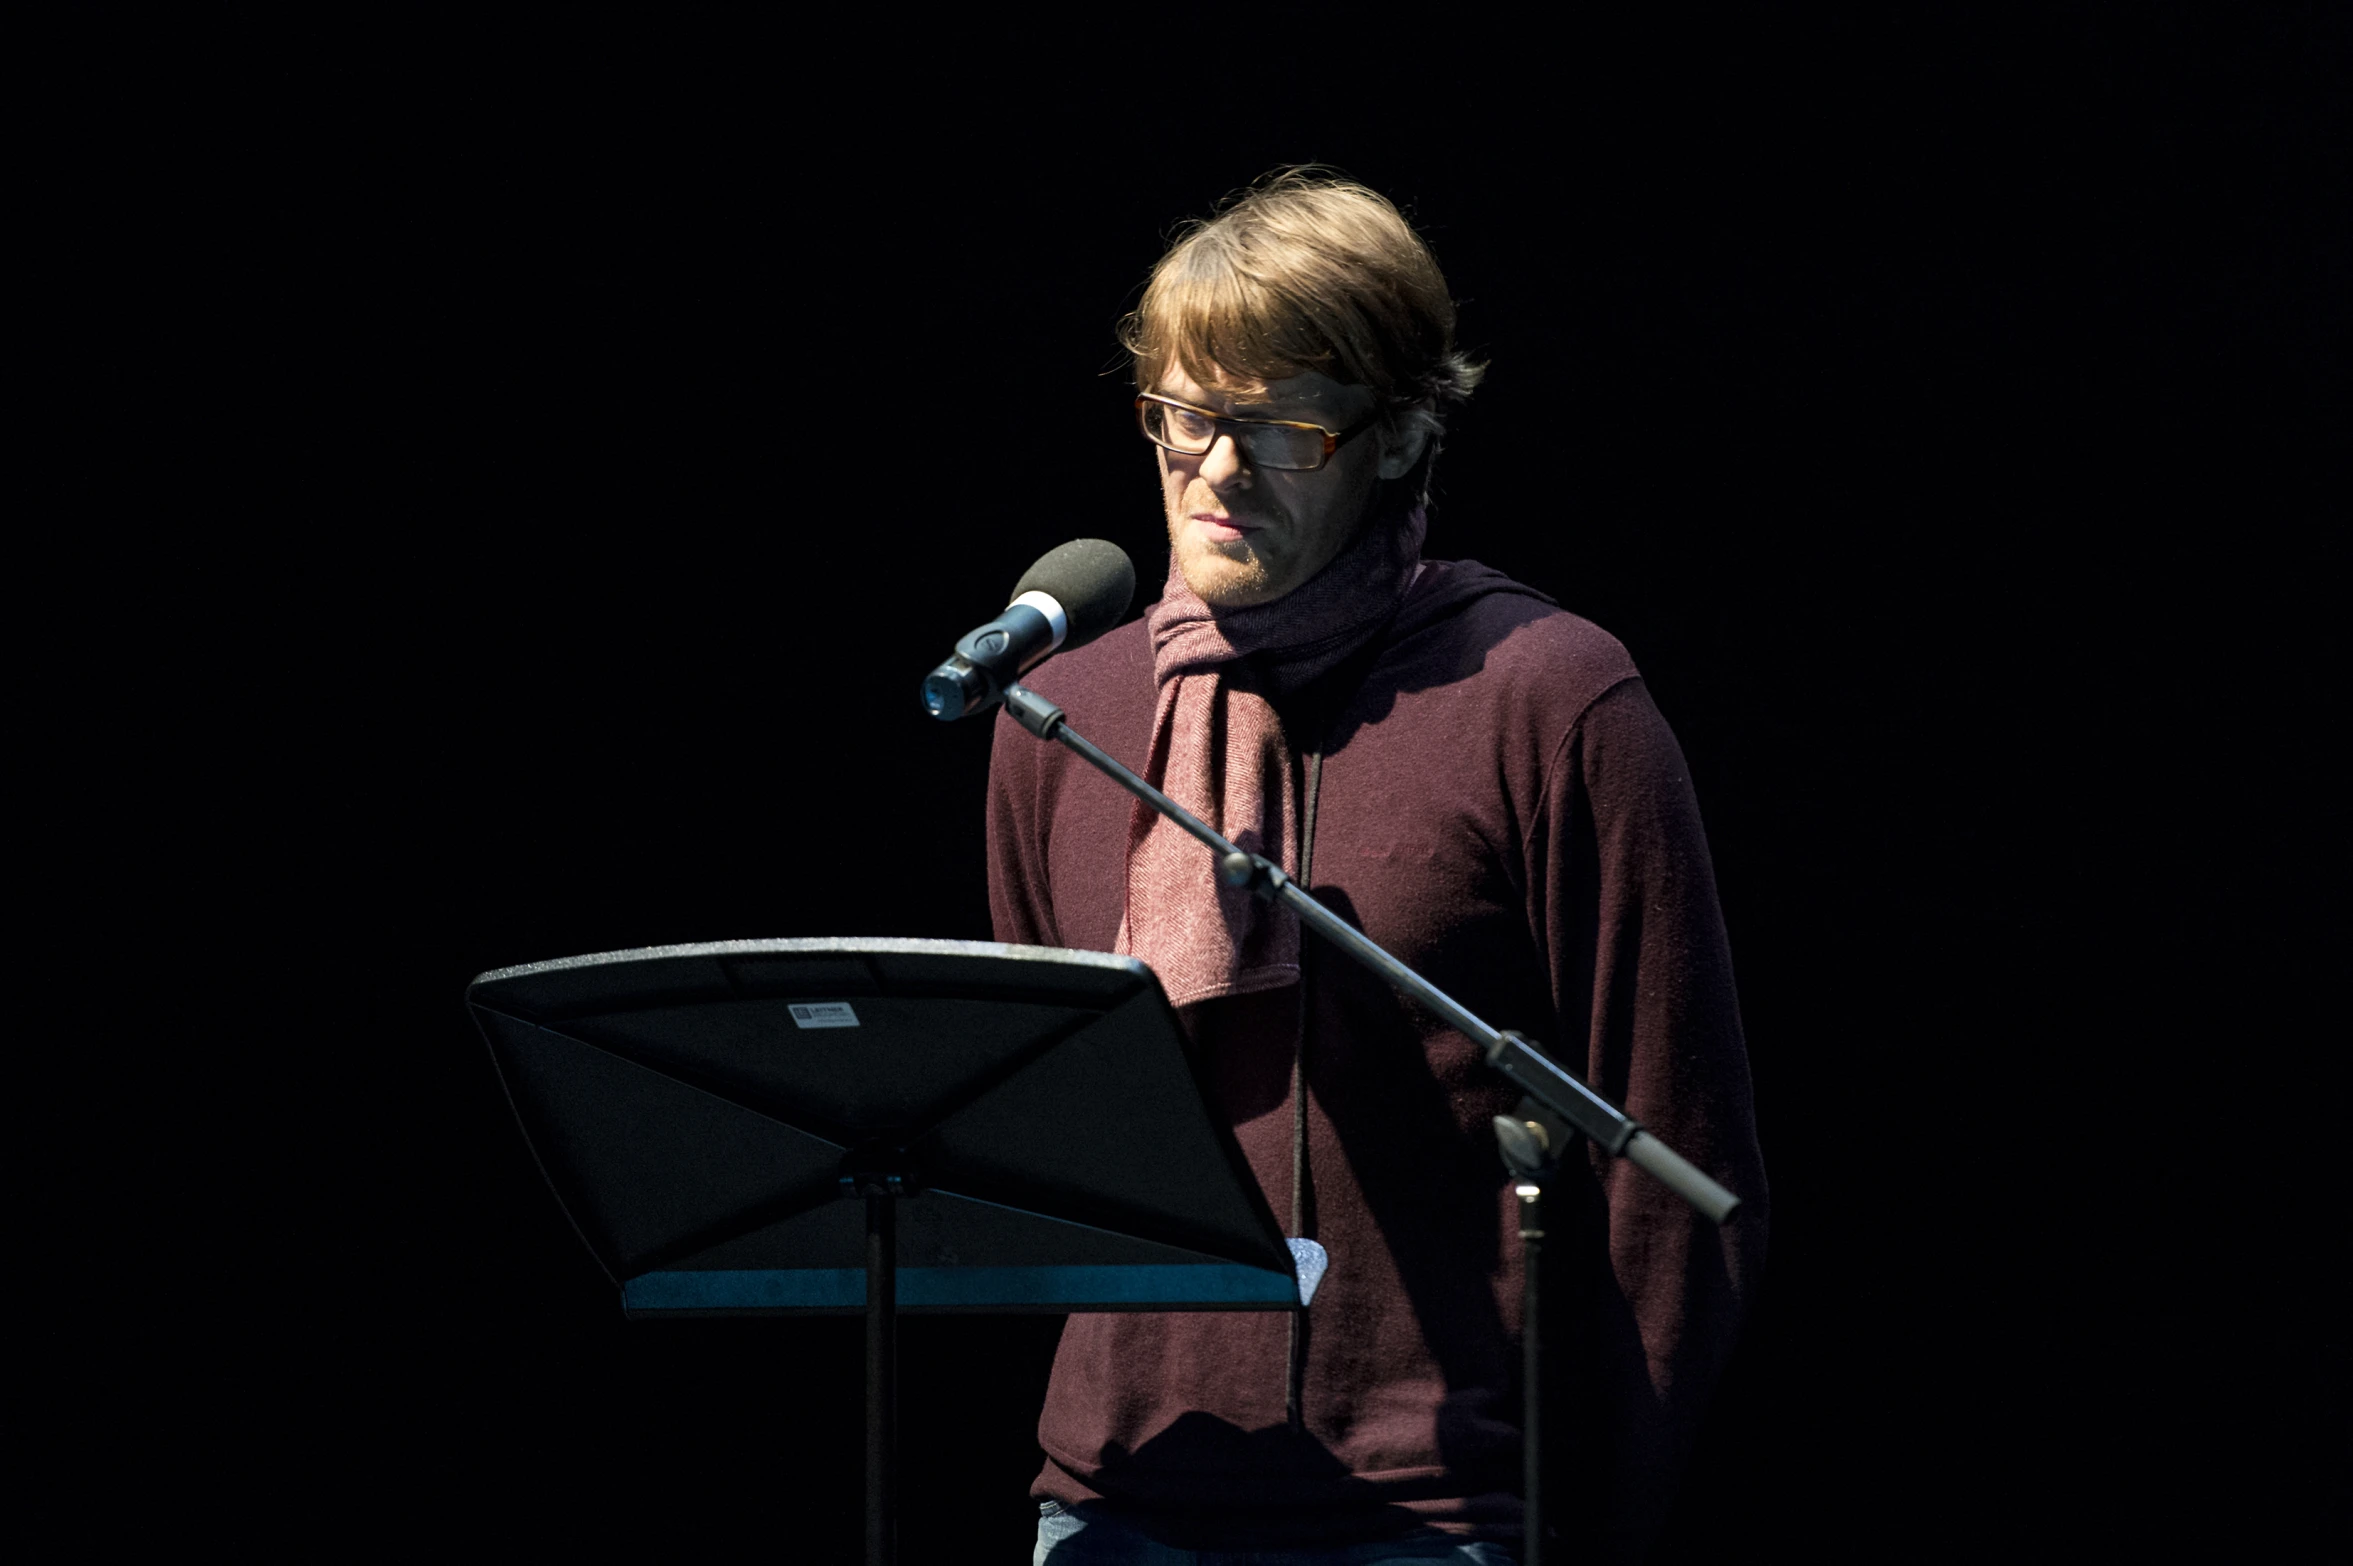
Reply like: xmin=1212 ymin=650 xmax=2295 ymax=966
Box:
xmin=1111 ymin=506 xmax=1426 ymax=1006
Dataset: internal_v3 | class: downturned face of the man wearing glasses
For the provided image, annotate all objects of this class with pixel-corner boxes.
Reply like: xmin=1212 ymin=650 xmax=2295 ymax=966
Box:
xmin=1153 ymin=364 xmax=1419 ymax=609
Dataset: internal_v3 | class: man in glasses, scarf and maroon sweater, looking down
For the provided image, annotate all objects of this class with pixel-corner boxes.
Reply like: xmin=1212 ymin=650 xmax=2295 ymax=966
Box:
xmin=988 ymin=172 xmax=1765 ymax=1566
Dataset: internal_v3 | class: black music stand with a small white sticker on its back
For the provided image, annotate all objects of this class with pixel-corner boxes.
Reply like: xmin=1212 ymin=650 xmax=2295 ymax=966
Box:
xmin=466 ymin=938 xmax=1301 ymax=1564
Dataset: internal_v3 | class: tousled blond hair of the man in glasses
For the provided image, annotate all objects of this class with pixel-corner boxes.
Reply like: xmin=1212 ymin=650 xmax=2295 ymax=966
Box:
xmin=1120 ymin=167 xmax=1487 ymax=498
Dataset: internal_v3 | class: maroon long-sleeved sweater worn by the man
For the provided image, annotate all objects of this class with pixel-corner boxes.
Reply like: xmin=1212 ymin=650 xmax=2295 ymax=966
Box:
xmin=988 ymin=562 xmax=1765 ymax=1559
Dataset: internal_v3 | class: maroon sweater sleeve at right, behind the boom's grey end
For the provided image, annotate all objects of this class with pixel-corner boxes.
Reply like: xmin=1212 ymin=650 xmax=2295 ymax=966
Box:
xmin=1529 ymin=677 xmax=1767 ymax=1559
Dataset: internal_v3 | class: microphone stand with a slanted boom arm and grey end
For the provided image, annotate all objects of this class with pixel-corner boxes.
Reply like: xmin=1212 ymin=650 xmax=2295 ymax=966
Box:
xmin=1005 ymin=682 xmax=1741 ymax=1566
